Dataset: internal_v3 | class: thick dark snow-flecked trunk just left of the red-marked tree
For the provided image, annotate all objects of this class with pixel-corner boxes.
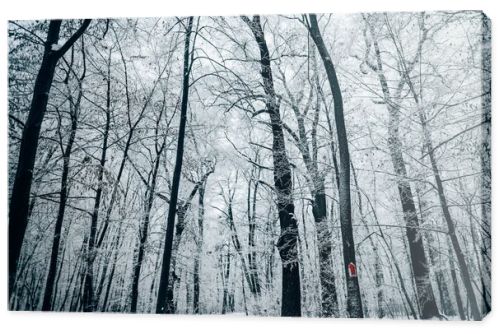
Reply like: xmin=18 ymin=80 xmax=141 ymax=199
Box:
xmin=242 ymin=15 xmax=301 ymax=316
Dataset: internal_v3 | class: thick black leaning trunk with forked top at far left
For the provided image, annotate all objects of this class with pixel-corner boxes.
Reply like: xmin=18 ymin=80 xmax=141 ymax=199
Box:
xmin=9 ymin=20 xmax=90 ymax=296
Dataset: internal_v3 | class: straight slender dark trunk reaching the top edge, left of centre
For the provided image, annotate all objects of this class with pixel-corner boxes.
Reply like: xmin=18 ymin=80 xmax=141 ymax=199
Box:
xmin=156 ymin=16 xmax=193 ymax=313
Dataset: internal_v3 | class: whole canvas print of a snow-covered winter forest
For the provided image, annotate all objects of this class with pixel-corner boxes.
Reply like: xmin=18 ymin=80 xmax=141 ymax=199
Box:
xmin=8 ymin=11 xmax=491 ymax=320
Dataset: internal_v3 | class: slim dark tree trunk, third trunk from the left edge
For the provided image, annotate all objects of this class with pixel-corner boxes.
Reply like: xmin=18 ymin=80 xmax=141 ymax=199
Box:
xmin=83 ymin=51 xmax=111 ymax=312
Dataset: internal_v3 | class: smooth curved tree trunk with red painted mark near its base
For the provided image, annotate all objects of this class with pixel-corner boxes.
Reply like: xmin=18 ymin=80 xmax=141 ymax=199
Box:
xmin=309 ymin=14 xmax=363 ymax=318
